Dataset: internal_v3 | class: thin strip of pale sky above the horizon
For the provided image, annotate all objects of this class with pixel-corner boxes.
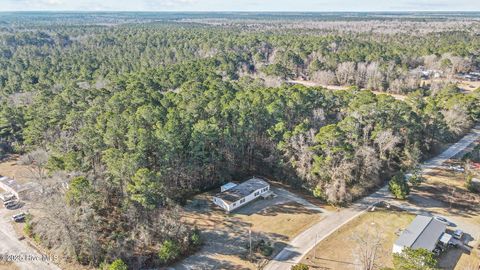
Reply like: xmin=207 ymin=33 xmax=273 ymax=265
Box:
xmin=0 ymin=0 xmax=480 ymax=12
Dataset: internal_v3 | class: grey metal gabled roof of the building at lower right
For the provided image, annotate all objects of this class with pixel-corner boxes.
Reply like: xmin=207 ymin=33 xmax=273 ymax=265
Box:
xmin=395 ymin=216 xmax=447 ymax=251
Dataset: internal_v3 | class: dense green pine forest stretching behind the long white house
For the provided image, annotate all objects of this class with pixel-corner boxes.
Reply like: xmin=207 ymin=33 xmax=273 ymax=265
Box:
xmin=0 ymin=15 xmax=480 ymax=267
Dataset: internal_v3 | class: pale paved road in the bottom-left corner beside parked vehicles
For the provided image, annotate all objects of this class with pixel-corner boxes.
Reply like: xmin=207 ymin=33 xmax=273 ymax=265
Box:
xmin=0 ymin=206 xmax=60 ymax=270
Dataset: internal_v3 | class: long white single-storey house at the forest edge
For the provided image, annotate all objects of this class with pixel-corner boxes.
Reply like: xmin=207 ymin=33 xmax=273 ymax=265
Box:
xmin=213 ymin=177 xmax=270 ymax=212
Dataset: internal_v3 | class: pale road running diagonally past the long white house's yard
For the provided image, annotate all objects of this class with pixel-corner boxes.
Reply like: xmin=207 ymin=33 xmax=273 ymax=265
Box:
xmin=264 ymin=126 xmax=480 ymax=270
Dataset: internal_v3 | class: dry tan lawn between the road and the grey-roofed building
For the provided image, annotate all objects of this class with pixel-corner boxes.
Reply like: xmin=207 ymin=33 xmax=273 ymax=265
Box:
xmin=302 ymin=208 xmax=415 ymax=270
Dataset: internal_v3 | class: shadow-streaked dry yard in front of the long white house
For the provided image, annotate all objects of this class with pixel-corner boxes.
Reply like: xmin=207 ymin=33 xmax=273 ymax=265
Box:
xmin=175 ymin=188 xmax=323 ymax=269
